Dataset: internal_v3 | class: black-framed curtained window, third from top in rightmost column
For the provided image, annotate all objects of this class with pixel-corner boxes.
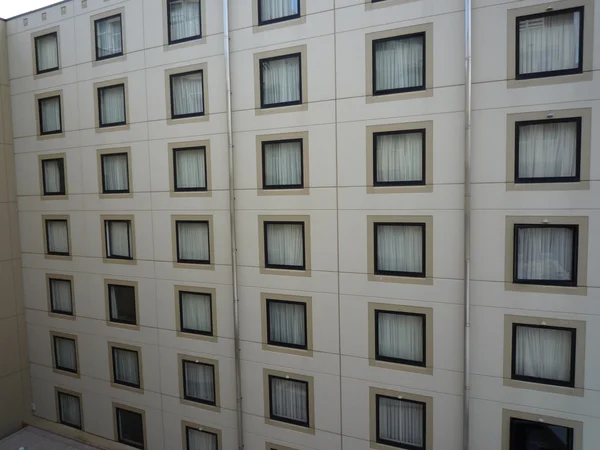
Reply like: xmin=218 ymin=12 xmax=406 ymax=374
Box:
xmin=513 ymin=224 xmax=579 ymax=286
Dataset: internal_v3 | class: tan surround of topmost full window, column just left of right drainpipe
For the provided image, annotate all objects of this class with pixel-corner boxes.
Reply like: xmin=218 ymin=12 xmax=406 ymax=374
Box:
xmin=365 ymin=23 xmax=434 ymax=103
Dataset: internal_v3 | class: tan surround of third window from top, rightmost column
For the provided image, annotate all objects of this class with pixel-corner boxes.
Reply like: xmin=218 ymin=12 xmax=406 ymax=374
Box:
xmin=504 ymin=216 xmax=589 ymax=295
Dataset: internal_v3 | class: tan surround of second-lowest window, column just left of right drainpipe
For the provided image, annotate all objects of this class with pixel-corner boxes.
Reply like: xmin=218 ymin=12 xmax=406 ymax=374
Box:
xmin=369 ymin=302 xmax=433 ymax=375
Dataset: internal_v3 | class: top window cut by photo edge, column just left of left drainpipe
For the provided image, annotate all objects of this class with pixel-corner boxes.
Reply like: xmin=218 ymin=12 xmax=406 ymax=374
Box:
xmin=167 ymin=0 xmax=202 ymax=44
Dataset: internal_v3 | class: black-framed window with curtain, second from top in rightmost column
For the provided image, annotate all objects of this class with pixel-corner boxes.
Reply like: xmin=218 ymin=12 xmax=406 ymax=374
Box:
xmin=515 ymin=117 xmax=581 ymax=183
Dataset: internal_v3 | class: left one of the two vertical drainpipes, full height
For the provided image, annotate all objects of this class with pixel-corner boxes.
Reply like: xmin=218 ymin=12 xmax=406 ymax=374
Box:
xmin=223 ymin=0 xmax=244 ymax=450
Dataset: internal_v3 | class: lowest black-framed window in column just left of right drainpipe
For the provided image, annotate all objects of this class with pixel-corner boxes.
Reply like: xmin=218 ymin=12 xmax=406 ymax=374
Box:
xmin=375 ymin=394 xmax=427 ymax=450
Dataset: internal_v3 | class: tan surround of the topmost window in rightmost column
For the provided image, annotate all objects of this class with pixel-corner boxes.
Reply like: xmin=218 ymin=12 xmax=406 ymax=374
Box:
xmin=506 ymin=0 xmax=594 ymax=89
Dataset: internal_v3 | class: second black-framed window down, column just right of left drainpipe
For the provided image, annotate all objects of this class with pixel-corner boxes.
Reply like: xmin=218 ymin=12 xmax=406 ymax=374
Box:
xmin=259 ymin=53 xmax=302 ymax=108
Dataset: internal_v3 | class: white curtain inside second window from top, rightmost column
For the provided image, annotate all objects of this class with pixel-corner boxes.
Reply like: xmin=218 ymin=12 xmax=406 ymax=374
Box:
xmin=519 ymin=122 xmax=577 ymax=178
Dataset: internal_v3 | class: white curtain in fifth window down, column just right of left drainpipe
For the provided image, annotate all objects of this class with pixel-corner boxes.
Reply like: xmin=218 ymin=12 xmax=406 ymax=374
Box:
xmin=267 ymin=300 xmax=306 ymax=346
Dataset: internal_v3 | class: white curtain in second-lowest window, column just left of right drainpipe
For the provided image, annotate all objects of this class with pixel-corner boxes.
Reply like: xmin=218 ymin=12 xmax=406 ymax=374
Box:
xmin=377 ymin=312 xmax=423 ymax=362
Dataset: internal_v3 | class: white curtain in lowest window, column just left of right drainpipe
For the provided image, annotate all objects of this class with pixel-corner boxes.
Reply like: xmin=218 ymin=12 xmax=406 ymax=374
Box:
xmin=378 ymin=397 xmax=425 ymax=447
